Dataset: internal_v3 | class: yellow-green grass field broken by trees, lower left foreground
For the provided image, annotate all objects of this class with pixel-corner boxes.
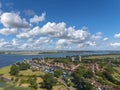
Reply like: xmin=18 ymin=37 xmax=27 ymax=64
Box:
xmin=0 ymin=66 xmax=67 ymax=90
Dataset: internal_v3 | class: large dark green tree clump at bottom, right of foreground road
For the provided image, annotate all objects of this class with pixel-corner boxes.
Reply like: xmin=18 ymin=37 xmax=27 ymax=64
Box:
xmin=72 ymin=67 xmax=94 ymax=90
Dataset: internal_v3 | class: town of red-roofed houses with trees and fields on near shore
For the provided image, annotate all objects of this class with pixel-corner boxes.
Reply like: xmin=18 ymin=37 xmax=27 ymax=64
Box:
xmin=1 ymin=55 xmax=120 ymax=90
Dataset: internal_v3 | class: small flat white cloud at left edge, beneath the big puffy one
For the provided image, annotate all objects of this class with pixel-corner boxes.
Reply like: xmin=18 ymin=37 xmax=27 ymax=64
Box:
xmin=0 ymin=28 xmax=17 ymax=35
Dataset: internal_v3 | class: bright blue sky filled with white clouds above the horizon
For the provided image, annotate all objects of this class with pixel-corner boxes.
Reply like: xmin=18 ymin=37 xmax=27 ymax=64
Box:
xmin=0 ymin=0 xmax=120 ymax=50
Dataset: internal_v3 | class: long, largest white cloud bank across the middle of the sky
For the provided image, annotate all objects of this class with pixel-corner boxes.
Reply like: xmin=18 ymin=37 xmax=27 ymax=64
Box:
xmin=17 ymin=22 xmax=90 ymax=43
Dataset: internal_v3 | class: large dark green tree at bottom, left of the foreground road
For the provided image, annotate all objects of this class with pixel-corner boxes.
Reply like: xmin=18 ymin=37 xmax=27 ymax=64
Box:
xmin=42 ymin=73 xmax=57 ymax=90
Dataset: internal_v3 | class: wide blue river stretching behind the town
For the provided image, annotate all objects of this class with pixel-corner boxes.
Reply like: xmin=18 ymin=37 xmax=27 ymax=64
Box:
xmin=0 ymin=52 xmax=117 ymax=68
